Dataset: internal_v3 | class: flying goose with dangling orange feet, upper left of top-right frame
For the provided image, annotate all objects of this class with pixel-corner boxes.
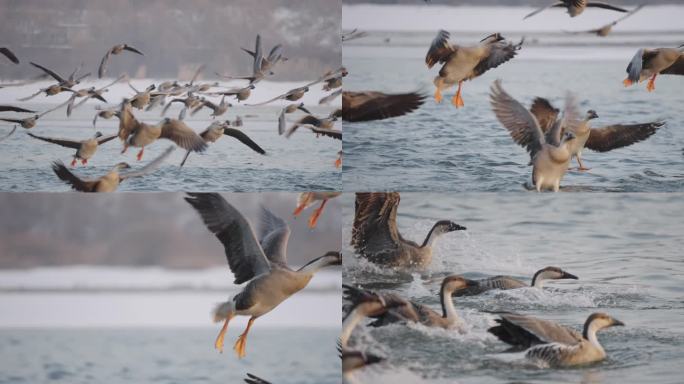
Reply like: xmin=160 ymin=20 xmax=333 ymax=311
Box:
xmin=425 ymin=30 xmax=523 ymax=108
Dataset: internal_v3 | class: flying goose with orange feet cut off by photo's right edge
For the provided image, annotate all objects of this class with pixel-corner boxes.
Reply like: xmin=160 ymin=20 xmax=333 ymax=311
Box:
xmin=622 ymin=44 xmax=684 ymax=92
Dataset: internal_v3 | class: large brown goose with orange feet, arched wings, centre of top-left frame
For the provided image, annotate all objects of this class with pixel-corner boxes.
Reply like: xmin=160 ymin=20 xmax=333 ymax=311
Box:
xmin=121 ymin=118 xmax=207 ymax=161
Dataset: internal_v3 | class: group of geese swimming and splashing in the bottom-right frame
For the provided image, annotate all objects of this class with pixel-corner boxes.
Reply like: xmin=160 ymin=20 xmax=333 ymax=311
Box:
xmin=340 ymin=192 xmax=624 ymax=378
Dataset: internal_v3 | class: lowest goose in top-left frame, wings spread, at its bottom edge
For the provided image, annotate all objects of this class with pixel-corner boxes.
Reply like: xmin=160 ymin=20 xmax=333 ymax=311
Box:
xmin=52 ymin=146 xmax=174 ymax=192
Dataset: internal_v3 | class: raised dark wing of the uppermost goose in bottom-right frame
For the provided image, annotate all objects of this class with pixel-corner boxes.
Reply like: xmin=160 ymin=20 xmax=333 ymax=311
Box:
xmin=351 ymin=192 xmax=401 ymax=253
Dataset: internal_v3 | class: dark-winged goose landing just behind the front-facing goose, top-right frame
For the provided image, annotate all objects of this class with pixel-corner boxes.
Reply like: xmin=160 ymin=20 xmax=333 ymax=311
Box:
xmin=530 ymin=97 xmax=665 ymax=171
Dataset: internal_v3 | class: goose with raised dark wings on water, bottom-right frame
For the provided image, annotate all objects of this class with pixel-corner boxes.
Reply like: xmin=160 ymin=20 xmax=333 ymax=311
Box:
xmin=351 ymin=192 xmax=466 ymax=268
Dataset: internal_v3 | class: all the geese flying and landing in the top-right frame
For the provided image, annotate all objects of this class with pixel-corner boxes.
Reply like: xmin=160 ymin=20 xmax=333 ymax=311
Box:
xmin=342 ymin=0 xmax=684 ymax=192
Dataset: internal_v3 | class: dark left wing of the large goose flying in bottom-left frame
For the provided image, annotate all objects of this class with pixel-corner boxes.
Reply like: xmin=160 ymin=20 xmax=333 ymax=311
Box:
xmin=185 ymin=193 xmax=271 ymax=284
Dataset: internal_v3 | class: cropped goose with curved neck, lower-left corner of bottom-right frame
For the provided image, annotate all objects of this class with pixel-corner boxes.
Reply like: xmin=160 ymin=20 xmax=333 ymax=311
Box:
xmin=339 ymin=290 xmax=403 ymax=375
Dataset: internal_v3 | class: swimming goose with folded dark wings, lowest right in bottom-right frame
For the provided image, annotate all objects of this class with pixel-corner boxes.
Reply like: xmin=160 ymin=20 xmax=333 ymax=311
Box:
xmin=487 ymin=312 xmax=625 ymax=367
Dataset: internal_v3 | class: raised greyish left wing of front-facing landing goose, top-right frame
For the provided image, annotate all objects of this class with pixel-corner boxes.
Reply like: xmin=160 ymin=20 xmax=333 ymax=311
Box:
xmin=490 ymin=80 xmax=545 ymax=158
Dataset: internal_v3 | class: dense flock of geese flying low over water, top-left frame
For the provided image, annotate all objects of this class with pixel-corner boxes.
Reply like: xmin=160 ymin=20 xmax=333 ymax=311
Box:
xmin=0 ymin=35 xmax=347 ymax=192
